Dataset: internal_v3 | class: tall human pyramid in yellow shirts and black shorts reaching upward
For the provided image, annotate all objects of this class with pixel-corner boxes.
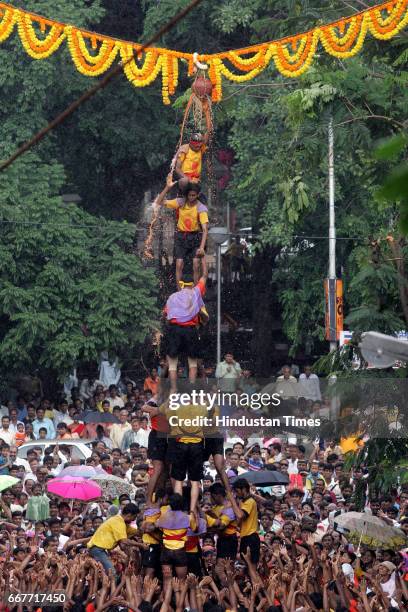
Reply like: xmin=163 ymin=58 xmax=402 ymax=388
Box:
xmin=88 ymin=93 xmax=260 ymax=589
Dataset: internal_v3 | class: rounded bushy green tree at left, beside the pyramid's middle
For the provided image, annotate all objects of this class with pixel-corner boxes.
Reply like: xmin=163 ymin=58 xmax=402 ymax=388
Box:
xmin=0 ymin=154 xmax=157 ymax=376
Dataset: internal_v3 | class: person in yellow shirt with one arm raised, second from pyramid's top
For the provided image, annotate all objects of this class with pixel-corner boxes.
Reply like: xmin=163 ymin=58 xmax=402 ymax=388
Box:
xmin=156 ymin=174 xmax=208 ymax=288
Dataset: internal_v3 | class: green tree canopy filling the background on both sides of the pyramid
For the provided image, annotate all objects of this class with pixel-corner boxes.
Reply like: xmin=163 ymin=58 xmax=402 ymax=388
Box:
xmin=0 ymin=0 xmax=408 ymax=374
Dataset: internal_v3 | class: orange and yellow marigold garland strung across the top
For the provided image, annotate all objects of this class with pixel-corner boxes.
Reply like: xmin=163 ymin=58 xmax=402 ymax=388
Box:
xmin=0 ymin=0 xmax=408 ymax=104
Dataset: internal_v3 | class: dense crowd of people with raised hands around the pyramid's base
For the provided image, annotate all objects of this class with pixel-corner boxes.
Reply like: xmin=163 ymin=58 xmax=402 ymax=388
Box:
xmin=0 ymin=368 xmax=408 ymax=612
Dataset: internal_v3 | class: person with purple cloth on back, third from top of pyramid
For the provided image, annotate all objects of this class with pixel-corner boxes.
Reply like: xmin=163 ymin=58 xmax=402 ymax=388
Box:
xmin=164 ymin=258 xmax=208 ymax=393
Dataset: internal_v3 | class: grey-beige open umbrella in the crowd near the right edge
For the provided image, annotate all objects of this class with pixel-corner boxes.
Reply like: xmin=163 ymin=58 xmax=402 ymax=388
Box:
xmin=334 ymin=512 xmax=407 ymax=549
